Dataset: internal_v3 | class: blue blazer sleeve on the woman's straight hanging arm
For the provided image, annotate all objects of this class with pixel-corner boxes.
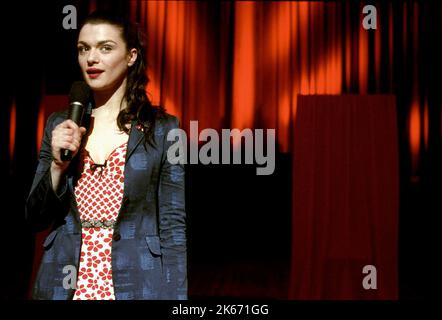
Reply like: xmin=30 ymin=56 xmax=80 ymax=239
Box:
xmin=158 ymin=117 xmax=187 ymax=300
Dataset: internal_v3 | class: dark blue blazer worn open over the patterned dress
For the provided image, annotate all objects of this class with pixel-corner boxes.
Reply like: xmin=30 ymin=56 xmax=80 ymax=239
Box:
xmin=26 ymin=110 xmax=187 ymax=300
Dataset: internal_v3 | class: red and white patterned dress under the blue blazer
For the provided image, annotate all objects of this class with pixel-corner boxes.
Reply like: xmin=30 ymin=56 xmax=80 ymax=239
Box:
xmin=73 ymin=142 xmax=127 ymax=300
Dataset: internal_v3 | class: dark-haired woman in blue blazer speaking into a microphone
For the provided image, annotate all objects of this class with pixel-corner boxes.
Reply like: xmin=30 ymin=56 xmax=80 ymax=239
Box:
xmin=26 ymin=12 xmax=187 ymax=300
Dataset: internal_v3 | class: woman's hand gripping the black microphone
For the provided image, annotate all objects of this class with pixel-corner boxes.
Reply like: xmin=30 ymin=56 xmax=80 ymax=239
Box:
xmin=51 ymin=119 xmax=86 ymax=172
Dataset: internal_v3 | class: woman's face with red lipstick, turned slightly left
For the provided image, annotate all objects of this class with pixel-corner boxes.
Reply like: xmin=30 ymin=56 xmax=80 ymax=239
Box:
xmin=77 ymin=23 xmax=137 ymax=91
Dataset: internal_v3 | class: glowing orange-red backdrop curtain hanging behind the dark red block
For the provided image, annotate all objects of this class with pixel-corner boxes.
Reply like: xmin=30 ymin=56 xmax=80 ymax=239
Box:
xmin=22 ymin=0 xmax=429 ymax=162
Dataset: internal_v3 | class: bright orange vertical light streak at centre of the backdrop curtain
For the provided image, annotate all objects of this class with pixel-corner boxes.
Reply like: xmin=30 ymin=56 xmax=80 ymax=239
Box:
xmin=232 ymin=2 xmax=255 ymax=129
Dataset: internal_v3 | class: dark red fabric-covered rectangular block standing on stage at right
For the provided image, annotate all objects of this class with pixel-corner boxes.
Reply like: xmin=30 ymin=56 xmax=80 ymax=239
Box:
xmin=289 ymin=95 xmax=399 ymax=299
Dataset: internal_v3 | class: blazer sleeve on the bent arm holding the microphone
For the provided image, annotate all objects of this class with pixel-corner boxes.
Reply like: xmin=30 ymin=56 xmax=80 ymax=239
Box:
xmin=25 ymin=113 xmax=68 ymax=231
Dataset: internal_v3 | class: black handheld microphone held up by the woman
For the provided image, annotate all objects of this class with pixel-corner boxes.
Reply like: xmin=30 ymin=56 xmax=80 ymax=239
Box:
xmin=60 ymin=81 xmax=91 ymax=161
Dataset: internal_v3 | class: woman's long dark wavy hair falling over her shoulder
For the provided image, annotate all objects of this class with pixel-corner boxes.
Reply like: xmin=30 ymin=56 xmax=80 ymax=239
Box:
xmin=80 ymin=10 xmax=165 ymax=146
